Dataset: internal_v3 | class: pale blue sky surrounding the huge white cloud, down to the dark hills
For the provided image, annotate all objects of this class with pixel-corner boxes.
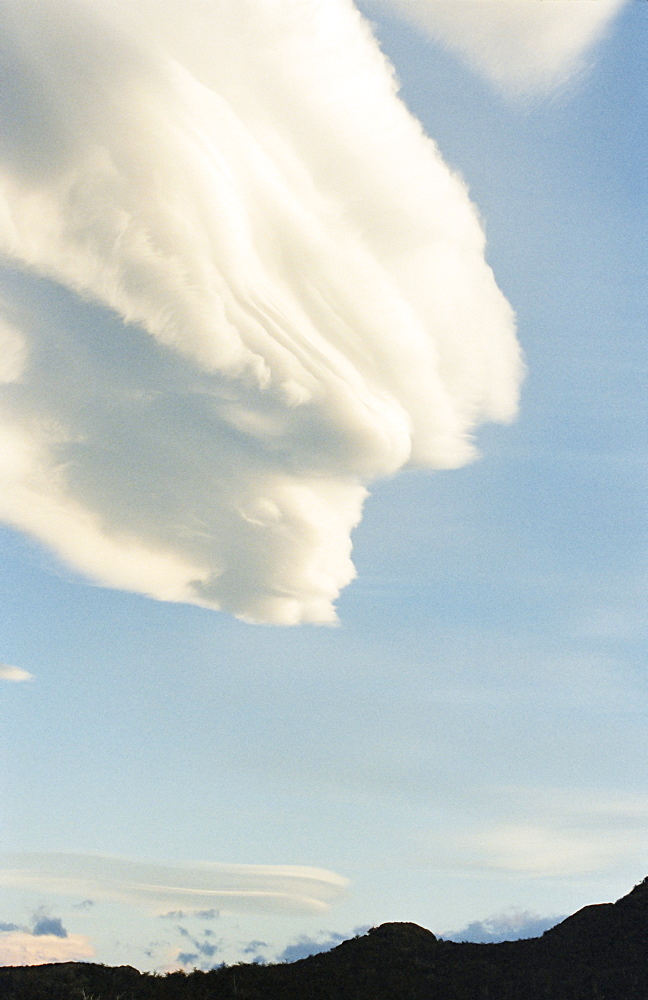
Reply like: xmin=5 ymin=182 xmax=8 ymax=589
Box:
xmin=0 ymin=0 xmax=648 ymax=969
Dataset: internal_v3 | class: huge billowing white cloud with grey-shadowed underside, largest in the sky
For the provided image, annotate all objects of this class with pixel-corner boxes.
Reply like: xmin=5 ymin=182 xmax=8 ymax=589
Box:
xmin=0 ymin=0 xmax=520 ymax=623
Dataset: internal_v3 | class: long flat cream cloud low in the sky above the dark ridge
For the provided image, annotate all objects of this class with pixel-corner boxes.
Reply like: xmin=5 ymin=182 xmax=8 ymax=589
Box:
xmin=0 ymin=854 xmax=347 ymax=913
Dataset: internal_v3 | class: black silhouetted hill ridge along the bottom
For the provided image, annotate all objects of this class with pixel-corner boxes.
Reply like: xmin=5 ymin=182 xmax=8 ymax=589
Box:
xmin=0 ymin=879 xmax=648 ymax=1000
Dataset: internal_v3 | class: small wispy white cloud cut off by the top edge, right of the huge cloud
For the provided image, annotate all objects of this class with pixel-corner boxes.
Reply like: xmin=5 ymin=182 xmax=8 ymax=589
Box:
xmin=378 ymin=0 xmax=624 ymax=93
